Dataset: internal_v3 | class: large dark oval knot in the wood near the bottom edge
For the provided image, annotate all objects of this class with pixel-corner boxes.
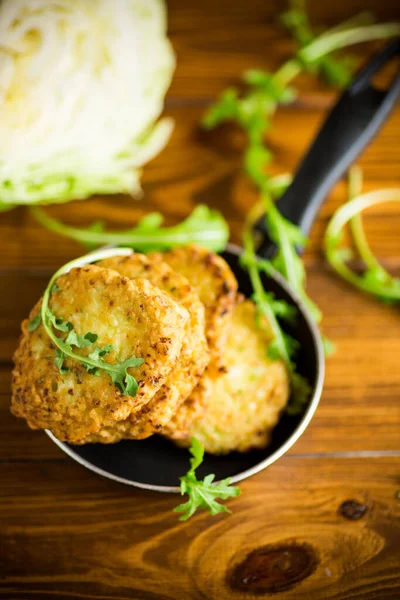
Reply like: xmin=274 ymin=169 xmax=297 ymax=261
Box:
xmin=228 ymin=543 xmax=318 ymax=594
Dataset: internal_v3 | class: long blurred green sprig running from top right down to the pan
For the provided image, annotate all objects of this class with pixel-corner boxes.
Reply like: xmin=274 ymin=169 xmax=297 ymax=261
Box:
xmin=202 ymin=1 xmax=400 ymax=344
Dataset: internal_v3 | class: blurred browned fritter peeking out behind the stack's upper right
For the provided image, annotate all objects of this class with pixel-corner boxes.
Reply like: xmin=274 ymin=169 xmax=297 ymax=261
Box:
xmin=149 ymin=245 xmax=238 ymax=371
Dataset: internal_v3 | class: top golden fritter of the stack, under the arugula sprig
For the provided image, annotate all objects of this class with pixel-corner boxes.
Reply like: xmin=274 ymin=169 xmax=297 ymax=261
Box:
xmin=12 ymin=266 xmax=189 ymax=442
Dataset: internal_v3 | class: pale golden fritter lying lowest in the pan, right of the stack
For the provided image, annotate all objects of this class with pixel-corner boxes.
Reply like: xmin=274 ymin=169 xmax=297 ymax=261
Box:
xmin=168 ymin=300 xmax=289 ymax=454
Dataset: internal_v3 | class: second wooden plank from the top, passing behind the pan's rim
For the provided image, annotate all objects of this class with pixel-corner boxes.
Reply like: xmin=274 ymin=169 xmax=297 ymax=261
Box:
xmin=0 ymin=106 xmax=400 ymax=272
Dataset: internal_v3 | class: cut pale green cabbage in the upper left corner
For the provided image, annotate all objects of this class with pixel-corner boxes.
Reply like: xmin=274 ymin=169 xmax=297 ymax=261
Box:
xmin=0 ymin=0 xmax=175 ymax=208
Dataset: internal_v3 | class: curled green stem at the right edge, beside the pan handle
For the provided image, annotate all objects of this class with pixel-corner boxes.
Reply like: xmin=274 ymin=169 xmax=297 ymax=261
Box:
xmin=324 ymin=167 xmax=400 ymax=303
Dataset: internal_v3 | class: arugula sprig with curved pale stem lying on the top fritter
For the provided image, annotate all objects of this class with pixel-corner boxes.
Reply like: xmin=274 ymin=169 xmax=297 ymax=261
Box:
xmin=38 ymin=248 xmax=144 ymax=396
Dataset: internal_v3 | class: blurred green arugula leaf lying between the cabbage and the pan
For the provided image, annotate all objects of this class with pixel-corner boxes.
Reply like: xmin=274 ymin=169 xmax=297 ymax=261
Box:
xmin=30 ymin=205 xmax=229 ymax=252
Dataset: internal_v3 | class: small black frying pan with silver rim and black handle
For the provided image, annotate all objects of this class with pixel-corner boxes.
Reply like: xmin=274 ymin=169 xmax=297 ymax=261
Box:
xmin=47 ymin=40 xmax=400 ymax=492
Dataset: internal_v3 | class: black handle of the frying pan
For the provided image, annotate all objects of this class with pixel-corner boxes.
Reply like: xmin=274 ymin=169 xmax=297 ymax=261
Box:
xmin=256 ymin=39 xmax=400 ymax=256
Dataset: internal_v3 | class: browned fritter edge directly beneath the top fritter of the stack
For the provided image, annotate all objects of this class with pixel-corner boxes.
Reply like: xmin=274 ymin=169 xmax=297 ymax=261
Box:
xmin=78 ymin=254 xmax=209 ymax=443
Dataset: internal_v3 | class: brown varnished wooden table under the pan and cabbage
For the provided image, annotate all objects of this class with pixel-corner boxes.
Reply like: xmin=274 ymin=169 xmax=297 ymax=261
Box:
xmin=0 ymin=0 xmax=400 ymax=600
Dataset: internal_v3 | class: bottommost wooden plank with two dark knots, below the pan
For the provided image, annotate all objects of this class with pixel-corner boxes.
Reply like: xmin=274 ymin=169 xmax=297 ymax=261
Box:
xmin=0 ymin=457 xmax=400 ymax=600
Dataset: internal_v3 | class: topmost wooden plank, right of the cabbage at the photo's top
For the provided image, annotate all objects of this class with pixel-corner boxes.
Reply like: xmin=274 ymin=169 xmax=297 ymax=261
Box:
xmin=168 ymin=0 xmax=398 ymax=100
